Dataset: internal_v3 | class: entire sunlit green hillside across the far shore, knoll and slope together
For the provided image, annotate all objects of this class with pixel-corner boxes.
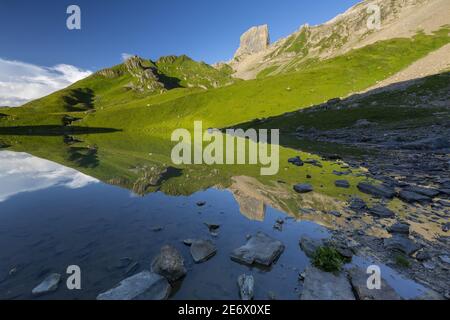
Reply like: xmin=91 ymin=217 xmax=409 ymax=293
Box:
xmin=0 ymin=28 xmax=450 ymax=139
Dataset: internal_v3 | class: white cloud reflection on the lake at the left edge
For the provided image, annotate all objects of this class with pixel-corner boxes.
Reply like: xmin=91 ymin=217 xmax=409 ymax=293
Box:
xmin=0 ymin=151 xmax=98 ymax=202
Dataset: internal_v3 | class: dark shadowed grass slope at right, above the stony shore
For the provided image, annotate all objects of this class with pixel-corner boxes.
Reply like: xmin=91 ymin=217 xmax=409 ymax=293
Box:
xmin=229 ymin=72 xmax=450 ymax=155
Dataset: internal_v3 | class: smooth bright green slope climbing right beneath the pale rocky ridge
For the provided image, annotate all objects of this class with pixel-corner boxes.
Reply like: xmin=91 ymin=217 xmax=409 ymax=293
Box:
xmin=82 ymin=29 xmax=450 ymax=137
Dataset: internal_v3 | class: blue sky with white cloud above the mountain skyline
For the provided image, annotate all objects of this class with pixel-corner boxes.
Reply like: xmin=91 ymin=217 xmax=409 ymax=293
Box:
xmin=0 ymin=0 xmax=359 ymax=106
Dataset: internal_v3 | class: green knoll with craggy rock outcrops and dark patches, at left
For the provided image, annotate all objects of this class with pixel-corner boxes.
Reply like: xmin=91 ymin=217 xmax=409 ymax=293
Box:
xmin=11 ymin=56 xmax=234 ymax=113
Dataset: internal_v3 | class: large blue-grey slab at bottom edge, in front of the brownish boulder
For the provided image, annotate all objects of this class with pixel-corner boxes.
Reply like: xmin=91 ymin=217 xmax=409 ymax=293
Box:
xmin=97 ymin=271 xmax=171 ymax=300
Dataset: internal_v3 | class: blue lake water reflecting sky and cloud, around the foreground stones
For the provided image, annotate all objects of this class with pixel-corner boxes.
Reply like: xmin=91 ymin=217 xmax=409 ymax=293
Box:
xmin=0 ymin=151 xmax=432 ymax=299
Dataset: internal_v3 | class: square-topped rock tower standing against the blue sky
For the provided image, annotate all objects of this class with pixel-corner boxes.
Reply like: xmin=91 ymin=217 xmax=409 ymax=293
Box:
xmin=234 ymin=24 xmax=270 ymax=59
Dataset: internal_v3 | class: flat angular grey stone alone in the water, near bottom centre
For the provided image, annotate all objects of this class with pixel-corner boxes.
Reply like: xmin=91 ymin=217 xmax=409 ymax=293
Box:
xmin=231 ymin=232 xmax=284 ymax=266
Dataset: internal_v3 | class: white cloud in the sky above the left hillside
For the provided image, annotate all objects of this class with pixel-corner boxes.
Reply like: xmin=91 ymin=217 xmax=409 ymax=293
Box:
xmin=0 ymin=58 xmax=92 ymax=107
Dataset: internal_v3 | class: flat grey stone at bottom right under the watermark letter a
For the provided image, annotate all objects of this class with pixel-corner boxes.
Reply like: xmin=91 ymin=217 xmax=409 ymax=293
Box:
xmin=349 ymin=268 xmax=401 ymax=300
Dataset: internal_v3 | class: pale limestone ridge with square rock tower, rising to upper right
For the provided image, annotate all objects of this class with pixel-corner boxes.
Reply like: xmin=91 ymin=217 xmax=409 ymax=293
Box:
xmin=229 ymin=0 xmax=450 ymax=79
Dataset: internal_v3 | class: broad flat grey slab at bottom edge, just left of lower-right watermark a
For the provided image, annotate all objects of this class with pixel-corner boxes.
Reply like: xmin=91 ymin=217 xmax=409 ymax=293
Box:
xmin=300 ymin=267 xmax=355 ymax=300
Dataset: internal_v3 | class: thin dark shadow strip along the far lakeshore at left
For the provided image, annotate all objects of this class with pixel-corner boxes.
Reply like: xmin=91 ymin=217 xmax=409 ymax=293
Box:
xmin=0 ymin=125 xmax=122 ymax=136
